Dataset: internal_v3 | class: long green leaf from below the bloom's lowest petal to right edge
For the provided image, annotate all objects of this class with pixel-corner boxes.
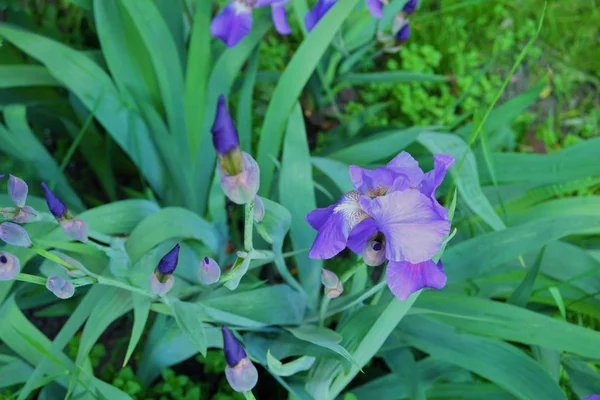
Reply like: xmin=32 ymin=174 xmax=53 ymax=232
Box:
xmin=415 ymin=291 xmax=600 ymax=359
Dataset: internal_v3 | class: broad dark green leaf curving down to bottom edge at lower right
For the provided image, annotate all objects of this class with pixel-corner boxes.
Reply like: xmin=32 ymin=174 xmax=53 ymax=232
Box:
xmin=398 ymin=316 xmax=566 ymax=400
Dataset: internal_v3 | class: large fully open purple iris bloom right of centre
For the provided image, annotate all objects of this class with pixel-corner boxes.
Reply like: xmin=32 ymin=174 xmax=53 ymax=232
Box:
xmin=307 ymin=152 xmax=454 ymax=300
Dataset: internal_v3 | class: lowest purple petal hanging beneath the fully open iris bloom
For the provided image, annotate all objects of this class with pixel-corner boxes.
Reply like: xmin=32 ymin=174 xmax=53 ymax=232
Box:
xmin=385 ymin=260 xmax=447 ymax=300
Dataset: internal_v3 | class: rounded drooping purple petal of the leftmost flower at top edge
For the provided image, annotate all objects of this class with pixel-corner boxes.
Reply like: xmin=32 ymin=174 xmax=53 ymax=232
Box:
xmin=210 ymin=2 xmax=252 ymax=47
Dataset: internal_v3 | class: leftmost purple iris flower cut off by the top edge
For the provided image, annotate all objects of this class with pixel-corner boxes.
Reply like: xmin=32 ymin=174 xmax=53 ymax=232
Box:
xmin=210 ymin=0 xmax=291 ymax=47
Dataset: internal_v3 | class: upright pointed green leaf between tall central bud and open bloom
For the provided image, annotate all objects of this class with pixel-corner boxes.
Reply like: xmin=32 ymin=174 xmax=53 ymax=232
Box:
xmin=279 ymin=104 xmax=323 ymax=308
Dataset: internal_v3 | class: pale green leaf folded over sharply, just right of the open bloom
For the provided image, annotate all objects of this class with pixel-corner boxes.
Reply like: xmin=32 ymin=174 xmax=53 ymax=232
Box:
xmin=417 ymin=133 xmax=506 ymax=231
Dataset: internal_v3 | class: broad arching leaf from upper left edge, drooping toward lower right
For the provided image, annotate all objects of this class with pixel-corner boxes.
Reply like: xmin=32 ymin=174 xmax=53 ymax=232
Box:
xmin=0 ymin=24 xmax=165 ymax=193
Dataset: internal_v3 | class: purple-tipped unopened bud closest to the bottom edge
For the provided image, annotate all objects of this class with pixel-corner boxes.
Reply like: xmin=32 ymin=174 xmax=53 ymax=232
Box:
xmin=222 ymin=327 xmax=258 ymax=393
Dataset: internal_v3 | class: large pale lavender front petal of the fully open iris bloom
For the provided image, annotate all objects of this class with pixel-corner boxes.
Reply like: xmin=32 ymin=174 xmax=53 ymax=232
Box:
xmin=361 ymin=190 xmax=450 ymax=263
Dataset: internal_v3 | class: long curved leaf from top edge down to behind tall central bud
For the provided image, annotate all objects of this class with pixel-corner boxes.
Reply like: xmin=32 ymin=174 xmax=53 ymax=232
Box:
xmin=257 ymin=0 xmax=358 ymax=196
